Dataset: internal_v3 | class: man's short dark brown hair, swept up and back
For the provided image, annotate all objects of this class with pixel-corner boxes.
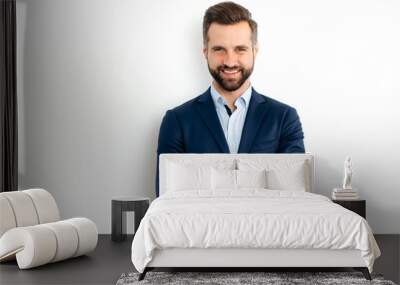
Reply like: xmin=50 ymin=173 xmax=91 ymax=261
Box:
xmin=203 ymin=2 xmax=257 ymax=46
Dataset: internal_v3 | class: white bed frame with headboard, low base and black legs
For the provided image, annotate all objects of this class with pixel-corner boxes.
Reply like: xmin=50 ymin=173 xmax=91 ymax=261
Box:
xmin=139 ymin=154 xmax=371 ymax=280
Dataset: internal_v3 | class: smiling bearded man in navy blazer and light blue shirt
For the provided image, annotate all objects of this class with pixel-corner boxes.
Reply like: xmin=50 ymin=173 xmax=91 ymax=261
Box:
xmin=156 ymin=2 xmax=305 ymax=197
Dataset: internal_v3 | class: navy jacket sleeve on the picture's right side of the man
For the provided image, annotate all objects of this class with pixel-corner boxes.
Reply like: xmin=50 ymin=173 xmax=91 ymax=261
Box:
xmin=278 ymin=107 xmax=305 ymax=153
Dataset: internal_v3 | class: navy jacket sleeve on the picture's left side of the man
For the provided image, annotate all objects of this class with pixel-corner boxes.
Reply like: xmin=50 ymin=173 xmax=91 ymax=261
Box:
xmin=155 ymin=110 xmax=185 ymax=197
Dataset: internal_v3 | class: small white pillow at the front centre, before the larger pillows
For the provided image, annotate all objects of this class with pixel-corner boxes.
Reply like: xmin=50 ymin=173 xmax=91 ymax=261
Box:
xmin=211 ymin=168 xmax=267 ymax=190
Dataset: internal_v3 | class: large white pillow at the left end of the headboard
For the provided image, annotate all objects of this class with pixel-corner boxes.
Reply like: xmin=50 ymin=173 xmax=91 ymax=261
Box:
xmin=166 ymin=162 xmax=211 ymax=191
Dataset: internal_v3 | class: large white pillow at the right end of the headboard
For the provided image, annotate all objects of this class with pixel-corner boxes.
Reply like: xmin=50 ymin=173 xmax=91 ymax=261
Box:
xmin=237 ymin=158 xmax=311 ymax=192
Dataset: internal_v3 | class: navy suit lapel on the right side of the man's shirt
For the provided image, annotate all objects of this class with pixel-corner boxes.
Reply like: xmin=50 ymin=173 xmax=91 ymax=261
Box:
xmin=238 ymin=88 xmax=268 ymax=153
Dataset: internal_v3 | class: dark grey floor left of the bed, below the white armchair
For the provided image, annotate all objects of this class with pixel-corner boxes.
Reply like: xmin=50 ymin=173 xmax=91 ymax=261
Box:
xmin=0 ymin=235 xmax=135 ymax=285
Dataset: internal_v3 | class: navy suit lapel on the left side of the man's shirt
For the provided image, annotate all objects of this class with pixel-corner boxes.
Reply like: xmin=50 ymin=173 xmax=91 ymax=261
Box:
xmin=196 ymin=88 xmax=229 ymax=153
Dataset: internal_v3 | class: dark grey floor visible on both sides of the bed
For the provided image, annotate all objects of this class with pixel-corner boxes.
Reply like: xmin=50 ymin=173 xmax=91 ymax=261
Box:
xmin=0 ymin=235 xmax=400 ymax=285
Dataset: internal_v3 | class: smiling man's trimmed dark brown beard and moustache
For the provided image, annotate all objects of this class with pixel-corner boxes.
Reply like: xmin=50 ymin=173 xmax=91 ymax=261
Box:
xmin=208 ymin=61 xmax=254 ymax=92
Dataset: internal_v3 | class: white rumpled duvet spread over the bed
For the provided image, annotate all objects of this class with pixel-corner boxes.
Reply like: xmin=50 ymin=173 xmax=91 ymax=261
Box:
xmin=132 ymin=189 xmax=380 ymax=272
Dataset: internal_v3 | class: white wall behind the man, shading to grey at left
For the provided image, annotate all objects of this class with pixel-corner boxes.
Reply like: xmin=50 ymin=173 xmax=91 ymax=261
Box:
xmin=17 ymin=0 xmax=400 ymax=233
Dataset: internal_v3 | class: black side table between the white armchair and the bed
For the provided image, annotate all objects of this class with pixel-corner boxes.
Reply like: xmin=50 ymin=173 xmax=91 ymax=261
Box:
xmin=111 ymin=197 xmax=150 ymax=241
